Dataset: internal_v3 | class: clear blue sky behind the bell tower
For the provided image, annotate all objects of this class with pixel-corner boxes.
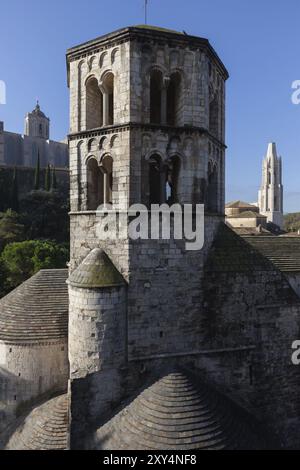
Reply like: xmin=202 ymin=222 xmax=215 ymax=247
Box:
xmin=0 ymin=0 xmax=300 ymax=212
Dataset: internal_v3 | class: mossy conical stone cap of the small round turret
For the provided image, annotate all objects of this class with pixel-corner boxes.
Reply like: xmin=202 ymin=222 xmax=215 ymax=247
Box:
xmin=68 ymin=248 xmax=125 ymax=289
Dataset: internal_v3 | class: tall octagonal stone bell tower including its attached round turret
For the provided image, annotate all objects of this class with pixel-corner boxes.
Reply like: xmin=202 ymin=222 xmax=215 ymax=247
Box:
xmin=67 ymin=26 xmax=228 ymax=448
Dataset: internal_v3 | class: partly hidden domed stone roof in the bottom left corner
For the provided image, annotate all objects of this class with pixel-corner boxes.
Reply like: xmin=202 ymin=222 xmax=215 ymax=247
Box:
xmin=6 ymin=395 xmax=68 ymax=450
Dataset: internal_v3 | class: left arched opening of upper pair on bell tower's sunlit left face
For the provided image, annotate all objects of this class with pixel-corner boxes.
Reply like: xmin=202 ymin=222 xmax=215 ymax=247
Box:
xmin=86 ymin=77 xmax=103 ymax=129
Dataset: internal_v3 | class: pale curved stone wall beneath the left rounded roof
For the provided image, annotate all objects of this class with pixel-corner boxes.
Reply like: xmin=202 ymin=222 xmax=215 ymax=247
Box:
xmin=0 ymin=339 xmax=69 ymax=442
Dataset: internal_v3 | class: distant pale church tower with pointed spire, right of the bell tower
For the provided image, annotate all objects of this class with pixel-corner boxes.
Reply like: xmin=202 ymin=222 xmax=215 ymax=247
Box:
xmin=258 ymin=143 xmax=283 ymax=228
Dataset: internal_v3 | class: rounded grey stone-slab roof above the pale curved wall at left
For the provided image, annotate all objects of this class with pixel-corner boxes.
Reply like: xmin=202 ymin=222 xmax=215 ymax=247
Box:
xmin=0 ymin=269 xmax=69 ymax=343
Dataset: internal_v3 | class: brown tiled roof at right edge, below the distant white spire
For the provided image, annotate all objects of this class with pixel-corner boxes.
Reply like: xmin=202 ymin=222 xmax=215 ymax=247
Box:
xmin=244 ymin=236 xmax=300 ymax=273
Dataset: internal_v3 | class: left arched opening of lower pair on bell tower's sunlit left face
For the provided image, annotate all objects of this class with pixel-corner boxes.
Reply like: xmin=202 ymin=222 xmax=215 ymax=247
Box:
xmin=87 ymin=157 xmax=104 ymax=211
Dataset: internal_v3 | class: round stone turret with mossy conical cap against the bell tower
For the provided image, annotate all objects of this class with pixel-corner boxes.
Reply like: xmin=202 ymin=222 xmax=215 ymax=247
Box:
xmin=68 ymin=248 xmax=127 ymax=449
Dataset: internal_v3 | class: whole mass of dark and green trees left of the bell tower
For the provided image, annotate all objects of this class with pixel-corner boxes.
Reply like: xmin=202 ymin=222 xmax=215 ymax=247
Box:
xmin=0 ymin=189 xmax=69 ymax=298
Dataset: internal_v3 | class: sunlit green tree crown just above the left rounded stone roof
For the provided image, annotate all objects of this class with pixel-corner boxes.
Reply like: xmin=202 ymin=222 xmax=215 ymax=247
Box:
xmin=1 ymin=240 xmax=69 ymax=290
